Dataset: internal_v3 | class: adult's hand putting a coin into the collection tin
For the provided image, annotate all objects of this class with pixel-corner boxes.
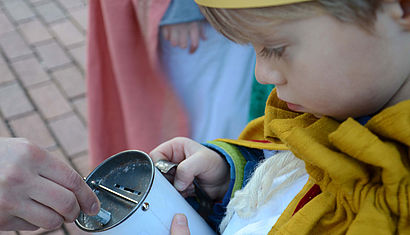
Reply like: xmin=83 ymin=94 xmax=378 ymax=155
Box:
xmin=0 ymin=138 xmax=100 ymax=230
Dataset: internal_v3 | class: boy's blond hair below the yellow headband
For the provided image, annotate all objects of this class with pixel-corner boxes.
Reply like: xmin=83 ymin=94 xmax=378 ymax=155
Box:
xmin=200 ymin=0 xmax=382 ymax=44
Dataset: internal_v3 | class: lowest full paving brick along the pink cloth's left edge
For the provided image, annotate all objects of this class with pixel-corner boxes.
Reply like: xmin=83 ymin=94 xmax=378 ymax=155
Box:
xmin=50 ymin=113 xmax=88 ymax=156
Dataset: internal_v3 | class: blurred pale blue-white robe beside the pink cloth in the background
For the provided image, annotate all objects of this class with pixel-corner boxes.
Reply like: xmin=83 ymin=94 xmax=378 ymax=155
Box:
xmin=160 ymin=24 xmax=255 ymax=142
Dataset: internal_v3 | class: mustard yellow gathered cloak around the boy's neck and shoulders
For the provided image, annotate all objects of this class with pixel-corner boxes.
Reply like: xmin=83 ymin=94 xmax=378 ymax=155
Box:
xmin=223 ymin=89 xmax=410 ymax=235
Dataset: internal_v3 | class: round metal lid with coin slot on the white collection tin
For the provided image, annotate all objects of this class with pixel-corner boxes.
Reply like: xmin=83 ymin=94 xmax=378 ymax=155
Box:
xmin=75 ymin=150 xmax=155 ymax=232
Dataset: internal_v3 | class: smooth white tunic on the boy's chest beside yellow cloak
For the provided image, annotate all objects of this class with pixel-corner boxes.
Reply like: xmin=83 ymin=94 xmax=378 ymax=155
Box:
xmin=223 ymin=151 xmax=308 ymax=235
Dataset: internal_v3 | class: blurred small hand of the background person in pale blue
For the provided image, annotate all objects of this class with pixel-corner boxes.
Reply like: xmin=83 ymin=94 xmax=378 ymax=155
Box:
xmin=160 ymin=21 xmax=205 ymax=53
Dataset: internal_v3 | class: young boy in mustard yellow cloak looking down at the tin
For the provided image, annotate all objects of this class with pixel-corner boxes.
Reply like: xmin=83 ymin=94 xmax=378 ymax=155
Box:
xmin=150 ymin=0 xmax=410 ymax=234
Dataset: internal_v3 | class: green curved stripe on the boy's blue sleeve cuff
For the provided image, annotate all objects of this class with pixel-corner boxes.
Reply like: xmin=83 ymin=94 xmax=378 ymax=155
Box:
xmin=207 ymin=140 xmax=246 ymax=198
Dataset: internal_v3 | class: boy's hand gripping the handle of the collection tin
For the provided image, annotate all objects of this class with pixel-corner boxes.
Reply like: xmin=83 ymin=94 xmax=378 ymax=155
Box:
xmin=150 ymin=137 xmax=229 ymax=200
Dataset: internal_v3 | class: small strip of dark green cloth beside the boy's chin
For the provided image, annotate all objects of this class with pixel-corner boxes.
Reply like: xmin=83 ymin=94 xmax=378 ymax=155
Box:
xmin=249 ymin=72 xmax=275 ymax=121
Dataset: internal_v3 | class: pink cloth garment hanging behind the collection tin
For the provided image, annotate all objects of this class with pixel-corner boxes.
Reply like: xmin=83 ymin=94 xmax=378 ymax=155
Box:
xmin=87 ymin=0 xmax=188 ymax=167
